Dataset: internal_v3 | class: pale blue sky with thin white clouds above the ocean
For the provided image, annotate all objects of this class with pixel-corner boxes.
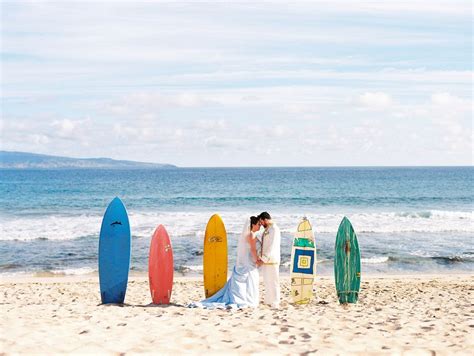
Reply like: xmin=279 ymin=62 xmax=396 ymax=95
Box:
xmin=0 ymin=0 xmax=473 ymax=167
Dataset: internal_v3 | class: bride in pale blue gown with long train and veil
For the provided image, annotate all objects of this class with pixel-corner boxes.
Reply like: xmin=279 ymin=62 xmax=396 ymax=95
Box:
xmin=190 ymin=216 xmax=260 ymax=309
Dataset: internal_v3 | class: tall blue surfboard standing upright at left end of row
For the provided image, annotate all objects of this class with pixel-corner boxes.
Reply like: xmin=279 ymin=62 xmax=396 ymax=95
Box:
xmin=99 ymin=197 xmax=132 ymax=304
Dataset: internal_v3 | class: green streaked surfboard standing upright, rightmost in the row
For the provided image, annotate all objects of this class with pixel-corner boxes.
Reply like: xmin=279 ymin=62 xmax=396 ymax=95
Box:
xmin=334 ymin=217 xmax=360 ymax=304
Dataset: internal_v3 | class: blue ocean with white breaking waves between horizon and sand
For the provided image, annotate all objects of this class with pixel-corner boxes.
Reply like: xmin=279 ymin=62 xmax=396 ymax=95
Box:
xmin=0 ymin=167 xmax=474 ymax=276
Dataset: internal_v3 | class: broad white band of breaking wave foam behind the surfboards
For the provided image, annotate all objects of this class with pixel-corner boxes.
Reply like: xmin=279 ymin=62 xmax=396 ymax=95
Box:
xmin=0 ymin=210 xmax=474 ymax=240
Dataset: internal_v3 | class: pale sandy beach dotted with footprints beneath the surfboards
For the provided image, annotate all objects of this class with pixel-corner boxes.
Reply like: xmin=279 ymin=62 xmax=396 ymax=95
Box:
xmin=0 ymin=274 xmax=474 ymax=355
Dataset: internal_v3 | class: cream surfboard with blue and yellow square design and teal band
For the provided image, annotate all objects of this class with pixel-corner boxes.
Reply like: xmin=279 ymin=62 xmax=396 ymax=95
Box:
xmin=290 ymin=218 xmax=316 ymax=304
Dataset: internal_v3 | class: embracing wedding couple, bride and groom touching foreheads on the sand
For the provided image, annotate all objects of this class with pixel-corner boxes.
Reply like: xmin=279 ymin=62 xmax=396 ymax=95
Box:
xmin=193 ymin=212 xmax=281 ymax=308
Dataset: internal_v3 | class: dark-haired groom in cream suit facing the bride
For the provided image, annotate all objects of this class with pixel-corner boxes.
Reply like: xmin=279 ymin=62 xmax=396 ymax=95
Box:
xmin=258 ymin=211 xmax=281 ymax=308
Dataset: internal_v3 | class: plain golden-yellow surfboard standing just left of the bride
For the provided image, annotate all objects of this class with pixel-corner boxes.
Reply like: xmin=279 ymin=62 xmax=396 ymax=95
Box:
xmin=203 ymin=214 xmax=227 ymax=298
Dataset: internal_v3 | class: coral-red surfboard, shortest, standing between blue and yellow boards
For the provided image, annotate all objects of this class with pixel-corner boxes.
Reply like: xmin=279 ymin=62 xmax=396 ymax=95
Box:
xmin=148 ymin=225 xmax=173 ymax=304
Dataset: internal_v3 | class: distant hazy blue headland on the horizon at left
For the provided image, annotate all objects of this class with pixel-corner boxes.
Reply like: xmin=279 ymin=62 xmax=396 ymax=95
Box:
xmin=0 ymin=151 xmax=177 ymax=169
